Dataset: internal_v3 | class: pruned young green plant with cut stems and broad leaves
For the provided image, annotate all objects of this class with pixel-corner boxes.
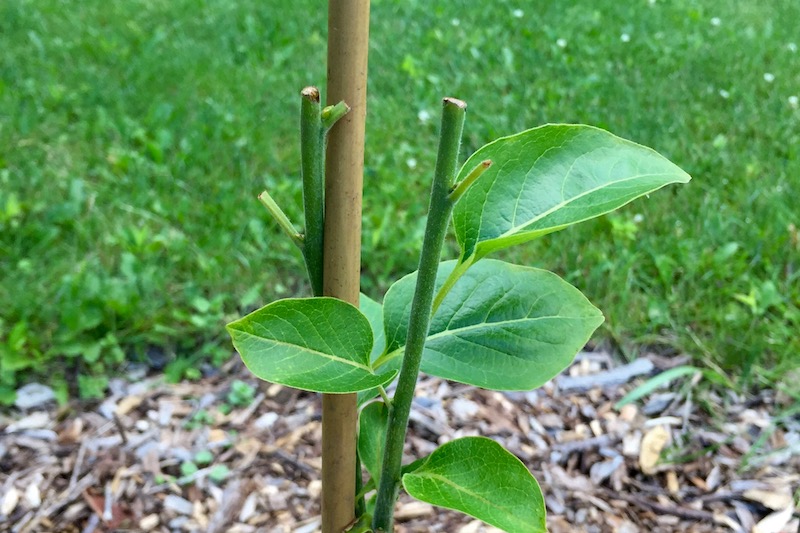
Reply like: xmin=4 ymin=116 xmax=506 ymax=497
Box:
xmin=228 ymin=89 xmax=690 ymax=532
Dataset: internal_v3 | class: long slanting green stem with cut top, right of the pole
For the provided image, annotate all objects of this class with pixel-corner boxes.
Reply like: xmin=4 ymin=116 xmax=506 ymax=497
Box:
xmin=372 ymin=98 xmax=467 ymax=532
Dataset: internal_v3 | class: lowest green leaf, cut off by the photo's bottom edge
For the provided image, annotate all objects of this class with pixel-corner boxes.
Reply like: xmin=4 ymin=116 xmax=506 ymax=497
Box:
xmin=403 ymin=437 xmax=547 ymax=533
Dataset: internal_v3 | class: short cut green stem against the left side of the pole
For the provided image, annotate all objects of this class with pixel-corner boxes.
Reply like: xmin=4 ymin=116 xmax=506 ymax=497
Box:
xmin=300 ymin=87 xmax=325 ymax=296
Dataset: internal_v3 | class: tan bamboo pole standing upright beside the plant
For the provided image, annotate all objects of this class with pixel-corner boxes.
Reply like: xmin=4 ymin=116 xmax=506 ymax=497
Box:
xmin=322 ymin=0 xmax=369 ymax=533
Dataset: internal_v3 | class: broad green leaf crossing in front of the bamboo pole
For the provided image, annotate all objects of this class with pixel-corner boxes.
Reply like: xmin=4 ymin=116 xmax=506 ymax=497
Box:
xmin=228 ymin=298 xmax=394 ymax=393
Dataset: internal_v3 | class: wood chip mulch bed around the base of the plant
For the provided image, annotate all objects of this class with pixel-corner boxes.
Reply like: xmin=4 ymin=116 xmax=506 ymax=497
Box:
xmin=0 ymin=352 xmax=800 ymax=533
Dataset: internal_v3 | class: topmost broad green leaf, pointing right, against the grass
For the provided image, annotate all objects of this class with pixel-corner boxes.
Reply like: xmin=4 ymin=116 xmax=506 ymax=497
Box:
xmin=453 ymin=124 xmax=691 ymax=258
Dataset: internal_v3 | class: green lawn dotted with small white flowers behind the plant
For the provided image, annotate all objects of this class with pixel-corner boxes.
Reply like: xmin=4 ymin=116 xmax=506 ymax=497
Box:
xmin=0 ymin=0 xmax=800 ymax=393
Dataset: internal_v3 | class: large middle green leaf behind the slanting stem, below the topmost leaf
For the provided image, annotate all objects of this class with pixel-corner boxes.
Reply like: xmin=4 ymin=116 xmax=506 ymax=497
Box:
xmin=384 ymin=259 xmax=603 ymax=390
